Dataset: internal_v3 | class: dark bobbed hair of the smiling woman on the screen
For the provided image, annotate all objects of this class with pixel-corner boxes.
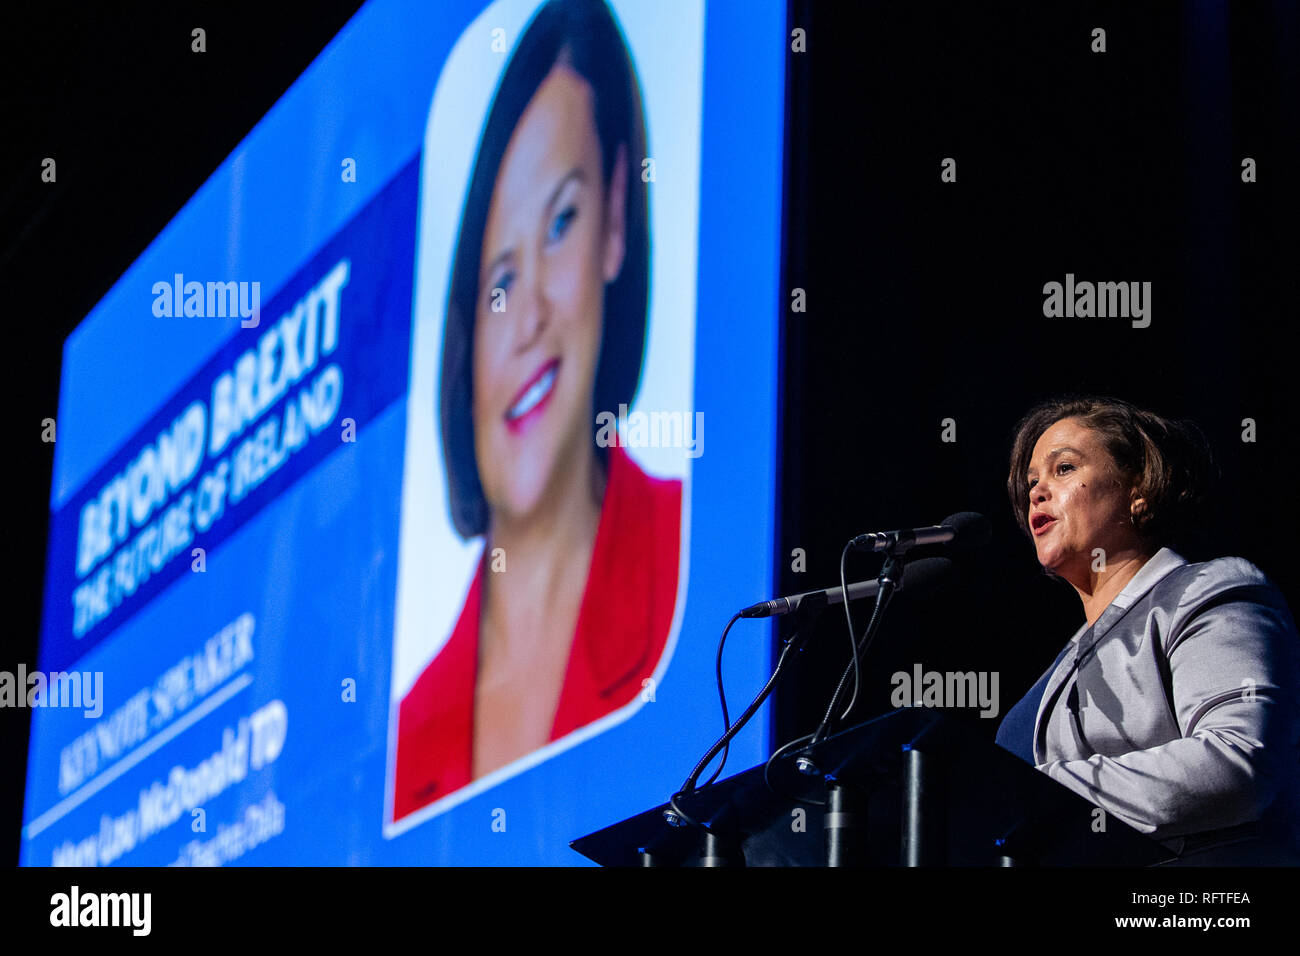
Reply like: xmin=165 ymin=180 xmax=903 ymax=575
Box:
xmin=438 ymin=0 xmax=650 ymax=538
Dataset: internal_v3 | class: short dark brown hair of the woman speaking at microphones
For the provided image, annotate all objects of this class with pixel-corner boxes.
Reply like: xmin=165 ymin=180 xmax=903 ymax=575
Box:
xmin=1006 ymin=395 xmax=1217 ymax=548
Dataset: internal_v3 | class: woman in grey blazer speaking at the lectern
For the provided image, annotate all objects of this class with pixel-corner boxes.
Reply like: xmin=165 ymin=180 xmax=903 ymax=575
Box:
xmin=997 ymin=398 xmax=1300 ymax=865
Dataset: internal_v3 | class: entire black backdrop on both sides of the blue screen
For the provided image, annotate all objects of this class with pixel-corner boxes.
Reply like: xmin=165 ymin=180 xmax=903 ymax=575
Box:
xmin=0 ymin=0 xmax=1300 ymax=862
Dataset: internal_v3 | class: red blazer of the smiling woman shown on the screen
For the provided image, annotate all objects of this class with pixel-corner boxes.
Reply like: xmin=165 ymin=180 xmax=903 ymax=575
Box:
xmin=393 ymin=446 xmax=681 ymax=821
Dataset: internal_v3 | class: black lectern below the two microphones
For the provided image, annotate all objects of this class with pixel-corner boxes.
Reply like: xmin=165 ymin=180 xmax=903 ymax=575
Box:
xmin=569 ymin=708 xmax=1173 ymax=866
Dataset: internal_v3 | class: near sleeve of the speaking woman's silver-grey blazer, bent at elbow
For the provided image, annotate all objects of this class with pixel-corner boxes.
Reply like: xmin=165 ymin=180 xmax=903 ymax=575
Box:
xmin=1039 ymin=558 xmax=1297 ymax=839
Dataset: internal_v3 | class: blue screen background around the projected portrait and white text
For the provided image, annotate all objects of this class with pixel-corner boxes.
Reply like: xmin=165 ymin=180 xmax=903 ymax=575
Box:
xmin=22 ymin=0 xmax=789 ymax=865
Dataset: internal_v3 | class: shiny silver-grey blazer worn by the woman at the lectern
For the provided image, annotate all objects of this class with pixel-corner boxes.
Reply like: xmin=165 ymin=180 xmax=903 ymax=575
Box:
xmin=1034 ymin=549 xmax=1300 ymax=861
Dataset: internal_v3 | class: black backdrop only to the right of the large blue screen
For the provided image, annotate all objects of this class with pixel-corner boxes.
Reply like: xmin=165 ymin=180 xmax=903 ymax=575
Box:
xmin=776 ymin=3 xmax=1300 ymax=764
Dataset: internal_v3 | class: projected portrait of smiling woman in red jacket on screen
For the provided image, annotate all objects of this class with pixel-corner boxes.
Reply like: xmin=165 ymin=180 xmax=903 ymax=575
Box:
xmin=393 ymin=0 xmax=681 ymax=819
